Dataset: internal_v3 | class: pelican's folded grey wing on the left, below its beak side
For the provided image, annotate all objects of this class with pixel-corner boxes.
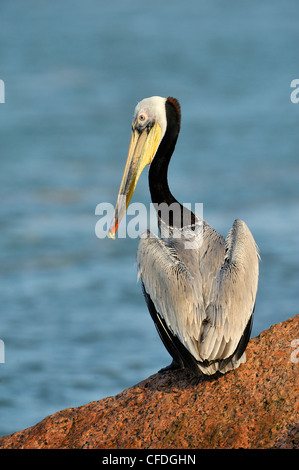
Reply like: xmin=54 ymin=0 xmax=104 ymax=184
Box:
xmin=137 ymin=229 xmax=204 ymax=358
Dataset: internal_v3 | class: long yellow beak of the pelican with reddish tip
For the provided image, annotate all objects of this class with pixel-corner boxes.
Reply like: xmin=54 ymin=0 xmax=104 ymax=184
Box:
xmin=109 ymin=121 xmax=162 ymax=238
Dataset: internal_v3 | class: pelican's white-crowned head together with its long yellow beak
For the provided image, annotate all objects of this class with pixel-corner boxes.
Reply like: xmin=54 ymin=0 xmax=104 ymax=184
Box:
xmin=109 ymin=96 xmax=167 ymax=238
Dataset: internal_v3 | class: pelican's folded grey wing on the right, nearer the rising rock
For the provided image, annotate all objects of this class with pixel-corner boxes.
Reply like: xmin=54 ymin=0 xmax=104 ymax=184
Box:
xmin=200 ymin=219 xmax=259 ymax=360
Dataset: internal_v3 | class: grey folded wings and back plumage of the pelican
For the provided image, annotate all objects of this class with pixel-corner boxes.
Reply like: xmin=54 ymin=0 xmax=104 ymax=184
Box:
xmin=137 ymin=220 xmax=258 ymax=361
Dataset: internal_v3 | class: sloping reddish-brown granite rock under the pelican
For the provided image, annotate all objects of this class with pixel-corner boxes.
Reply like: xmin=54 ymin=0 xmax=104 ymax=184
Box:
xmin=0 ymin=315 xmax=299 ymax=449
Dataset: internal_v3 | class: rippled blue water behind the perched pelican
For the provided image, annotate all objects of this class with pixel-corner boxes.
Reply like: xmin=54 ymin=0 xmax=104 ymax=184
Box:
xmin=0 ymin=0 xmax=299 ymax=435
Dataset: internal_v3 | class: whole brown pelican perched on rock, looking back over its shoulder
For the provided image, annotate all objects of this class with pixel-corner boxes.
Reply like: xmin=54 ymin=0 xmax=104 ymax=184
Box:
xmin=109 ymin=96 xmax=259 ymax=375
